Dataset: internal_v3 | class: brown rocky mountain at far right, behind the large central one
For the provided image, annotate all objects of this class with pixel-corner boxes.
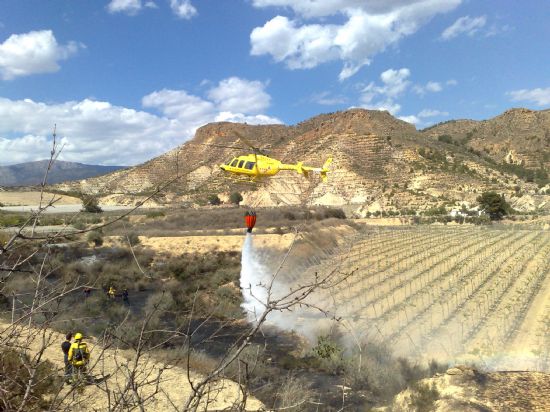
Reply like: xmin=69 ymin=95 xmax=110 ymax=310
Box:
xmin=422 ymin=109 xmax=550 ymax=170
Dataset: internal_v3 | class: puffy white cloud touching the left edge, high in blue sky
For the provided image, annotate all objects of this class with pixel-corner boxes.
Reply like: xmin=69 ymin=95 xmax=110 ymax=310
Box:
xmin=0 ymin=30 xmax=84 ymax=80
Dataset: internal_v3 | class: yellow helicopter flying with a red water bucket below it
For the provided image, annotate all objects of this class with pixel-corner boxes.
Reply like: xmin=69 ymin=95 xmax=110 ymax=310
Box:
xmin=220 ymin=132 xmax=332 ymax=182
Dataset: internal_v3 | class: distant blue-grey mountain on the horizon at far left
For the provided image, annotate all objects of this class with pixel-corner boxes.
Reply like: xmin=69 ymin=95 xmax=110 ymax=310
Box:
xmin=0 ymin=160 xmax=122 ymax=186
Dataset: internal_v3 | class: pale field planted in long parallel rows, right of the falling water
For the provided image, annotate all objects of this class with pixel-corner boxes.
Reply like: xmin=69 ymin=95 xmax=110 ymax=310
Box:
xmin=287 ymin=226 xmax=550 ymax=371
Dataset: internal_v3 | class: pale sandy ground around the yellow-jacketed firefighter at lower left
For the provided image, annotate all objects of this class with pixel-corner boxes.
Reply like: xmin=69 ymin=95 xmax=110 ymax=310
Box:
xmin=0 ymin=322 xmax=262 ymax=411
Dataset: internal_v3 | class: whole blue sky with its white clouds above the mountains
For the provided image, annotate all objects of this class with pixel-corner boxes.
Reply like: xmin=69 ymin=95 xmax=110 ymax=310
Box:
xmin=0 ymin=0 xmax=550 ymax=165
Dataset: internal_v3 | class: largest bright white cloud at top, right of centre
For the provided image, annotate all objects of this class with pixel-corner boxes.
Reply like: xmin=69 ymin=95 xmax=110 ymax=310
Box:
xmin=250 ymin=0 xmax=461 ymax=80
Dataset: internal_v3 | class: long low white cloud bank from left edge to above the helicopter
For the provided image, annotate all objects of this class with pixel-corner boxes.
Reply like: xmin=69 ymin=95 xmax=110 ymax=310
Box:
xmin=0 ymin=77 xmax=281 ymax=165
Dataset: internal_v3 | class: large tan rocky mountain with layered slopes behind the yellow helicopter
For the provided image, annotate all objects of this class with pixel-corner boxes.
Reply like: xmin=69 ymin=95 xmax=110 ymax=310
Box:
xmin=52 ymin=109 xmax=550 ymax=216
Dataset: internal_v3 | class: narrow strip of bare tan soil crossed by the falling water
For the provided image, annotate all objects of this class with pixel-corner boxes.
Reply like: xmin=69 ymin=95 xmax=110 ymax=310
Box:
xmin=139 ymin=233 xmax=294 ymax=255
